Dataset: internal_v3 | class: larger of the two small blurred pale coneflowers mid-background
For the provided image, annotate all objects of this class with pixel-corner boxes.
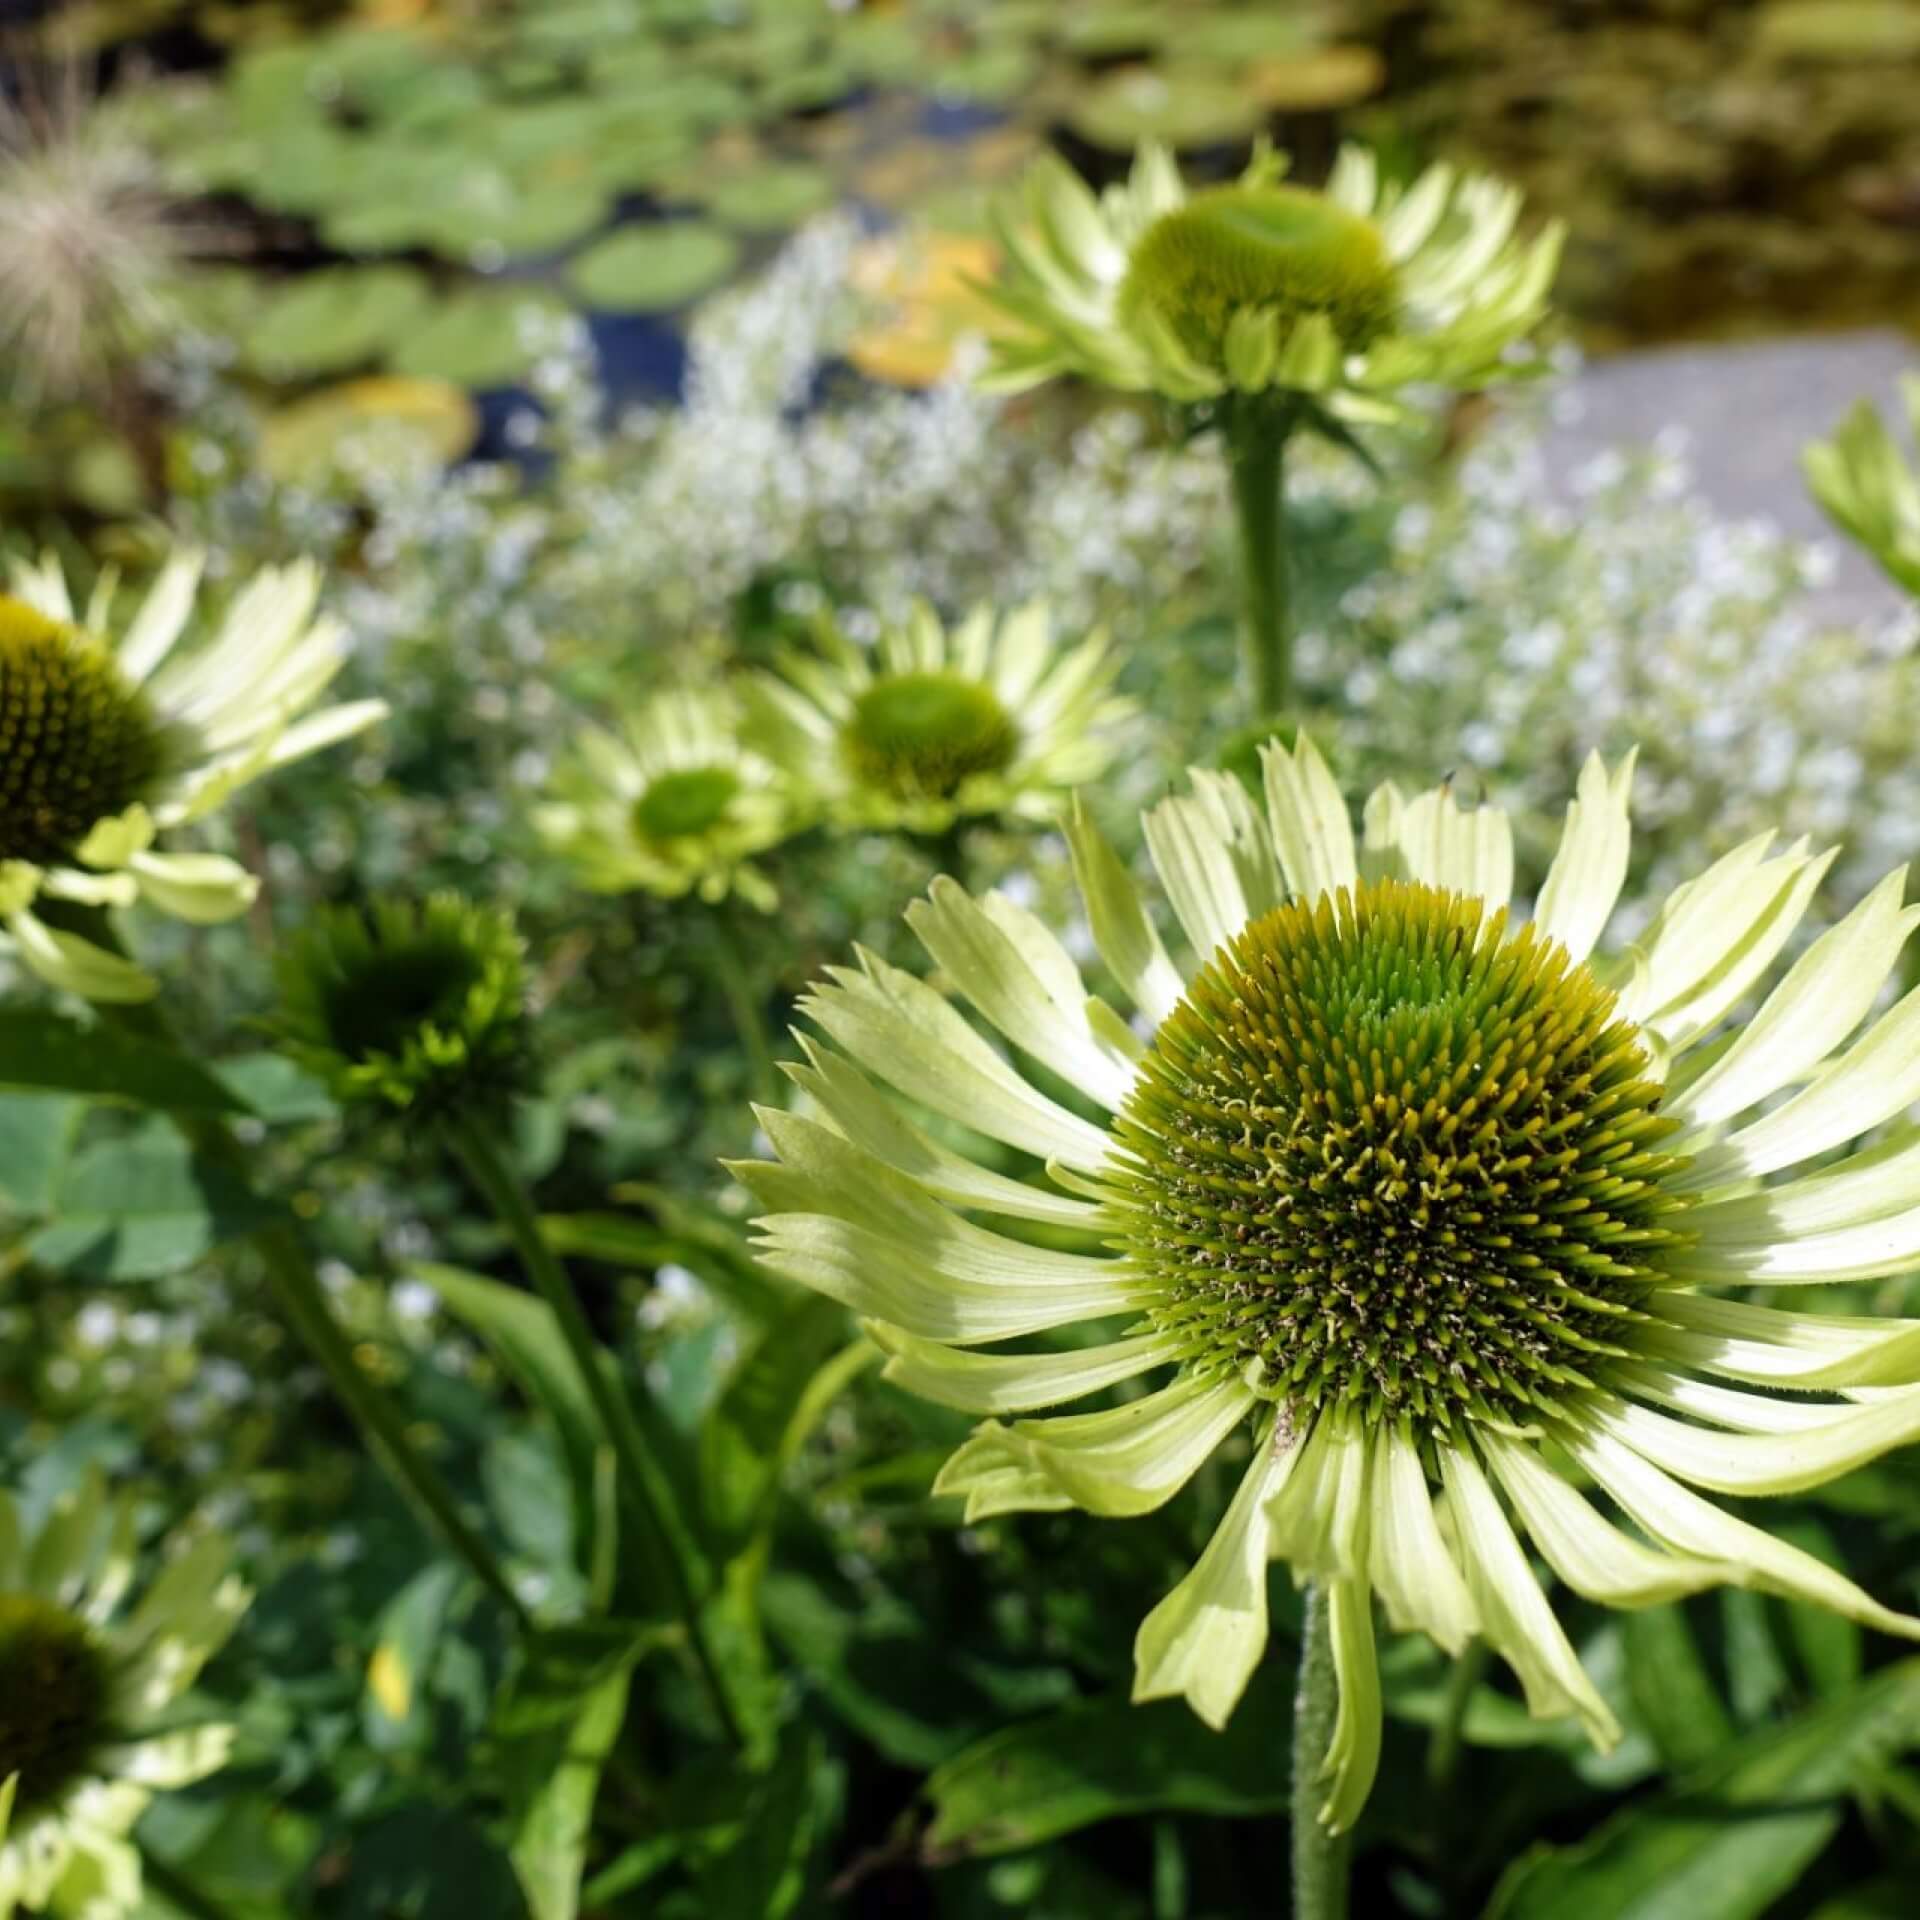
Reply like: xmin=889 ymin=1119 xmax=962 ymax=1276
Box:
xmin=749 ymin=603 xmax=1135 ymax=833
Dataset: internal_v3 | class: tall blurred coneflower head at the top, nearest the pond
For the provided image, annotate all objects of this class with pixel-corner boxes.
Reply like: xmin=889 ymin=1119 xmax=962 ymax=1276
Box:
xmin=987 ymin=146 xmax=1561 ymax=415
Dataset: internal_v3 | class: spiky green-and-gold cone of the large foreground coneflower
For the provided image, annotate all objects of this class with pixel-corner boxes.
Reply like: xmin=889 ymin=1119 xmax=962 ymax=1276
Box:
xmin=1116 ymin=879 xmax=1682 ymax=1432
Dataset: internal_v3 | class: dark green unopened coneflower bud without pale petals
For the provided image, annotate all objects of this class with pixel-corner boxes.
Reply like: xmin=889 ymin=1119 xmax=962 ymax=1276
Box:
xmin=276 ymin=893 xmax=526 ymax=1119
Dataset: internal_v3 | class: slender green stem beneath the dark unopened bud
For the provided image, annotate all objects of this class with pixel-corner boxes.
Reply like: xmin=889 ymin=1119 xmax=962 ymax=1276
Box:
xmin=444 ymin=1116 xmax=743 ymax=1745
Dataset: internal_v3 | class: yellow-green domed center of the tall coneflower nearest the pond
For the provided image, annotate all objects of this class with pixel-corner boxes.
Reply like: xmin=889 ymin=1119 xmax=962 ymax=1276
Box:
xmin=1119 ymin=186 xmax=1398 ymax=367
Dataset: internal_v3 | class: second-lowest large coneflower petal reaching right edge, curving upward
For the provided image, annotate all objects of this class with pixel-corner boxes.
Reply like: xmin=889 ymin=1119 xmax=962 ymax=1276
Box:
xmin=1586 ymin=1388 xmax=1920 ymax=1494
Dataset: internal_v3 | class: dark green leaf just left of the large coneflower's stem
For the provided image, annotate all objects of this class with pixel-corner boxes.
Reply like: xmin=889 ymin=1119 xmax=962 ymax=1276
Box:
xmin=922 ymin=1661 xmax=1297 ymax=1850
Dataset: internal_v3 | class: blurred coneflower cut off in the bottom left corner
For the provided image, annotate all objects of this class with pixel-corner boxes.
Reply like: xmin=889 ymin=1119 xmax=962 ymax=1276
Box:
xmin=0 ymin=1480 xmax=248 ymax=1920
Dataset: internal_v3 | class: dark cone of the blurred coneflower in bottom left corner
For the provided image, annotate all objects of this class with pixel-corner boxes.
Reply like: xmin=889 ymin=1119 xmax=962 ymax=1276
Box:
xmin=0 ymin=1594 xmax=109 ymax=1809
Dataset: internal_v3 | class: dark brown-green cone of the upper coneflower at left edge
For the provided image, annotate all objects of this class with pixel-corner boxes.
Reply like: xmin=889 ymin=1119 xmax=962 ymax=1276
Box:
xmin=0 ymin=593 xmax=167 ymax=866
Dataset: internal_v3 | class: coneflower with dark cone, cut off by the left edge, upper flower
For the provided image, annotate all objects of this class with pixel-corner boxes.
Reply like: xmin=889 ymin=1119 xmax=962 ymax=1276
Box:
xmin=0 ymin=553 xmax=386 ymax=1000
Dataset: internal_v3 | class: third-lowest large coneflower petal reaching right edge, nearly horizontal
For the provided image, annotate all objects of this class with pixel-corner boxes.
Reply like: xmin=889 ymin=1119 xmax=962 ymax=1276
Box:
xmin=1642 ymin=1290 xmax=1920 ymax=1392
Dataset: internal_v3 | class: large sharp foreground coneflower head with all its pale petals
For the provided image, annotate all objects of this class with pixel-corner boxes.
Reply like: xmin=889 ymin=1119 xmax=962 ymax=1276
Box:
xmin=737 ymin=737 xmax=1920 ymax=1828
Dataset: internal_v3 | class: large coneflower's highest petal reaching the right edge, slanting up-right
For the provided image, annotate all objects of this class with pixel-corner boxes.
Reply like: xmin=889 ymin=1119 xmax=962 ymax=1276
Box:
xmin=1672 ymin=868 xmax=1920 ymax=1127
